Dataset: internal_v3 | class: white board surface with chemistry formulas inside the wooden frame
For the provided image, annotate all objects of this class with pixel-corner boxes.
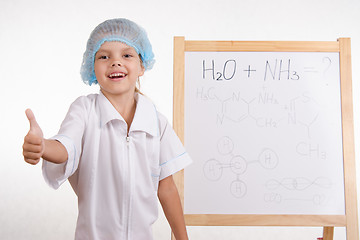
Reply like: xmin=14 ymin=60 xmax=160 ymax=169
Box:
xmin=184 ymin=52 xmax=345 ymax=215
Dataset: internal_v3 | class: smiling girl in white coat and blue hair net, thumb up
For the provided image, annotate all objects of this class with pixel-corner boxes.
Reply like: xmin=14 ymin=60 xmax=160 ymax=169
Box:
xmin=23 ymin=19 xmax=191 ymax=240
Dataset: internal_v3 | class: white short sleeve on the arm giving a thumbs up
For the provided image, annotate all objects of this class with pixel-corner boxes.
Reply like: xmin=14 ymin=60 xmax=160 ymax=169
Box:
xmin=42 ymin=97 xmax=88 ymax=189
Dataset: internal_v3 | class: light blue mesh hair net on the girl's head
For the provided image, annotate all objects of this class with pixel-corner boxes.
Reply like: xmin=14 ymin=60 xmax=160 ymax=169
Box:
xmin=80 ymin=18 xmax=155 ymax=85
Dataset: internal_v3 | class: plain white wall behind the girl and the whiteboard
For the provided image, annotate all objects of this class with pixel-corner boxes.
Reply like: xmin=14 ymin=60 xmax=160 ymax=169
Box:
xmin=0 ymin=0 xmax=360 ymax=240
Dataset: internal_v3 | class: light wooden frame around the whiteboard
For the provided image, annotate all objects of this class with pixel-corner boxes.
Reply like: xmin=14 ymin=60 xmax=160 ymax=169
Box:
xmin=172 ymin=37 xmax=359 ymax=240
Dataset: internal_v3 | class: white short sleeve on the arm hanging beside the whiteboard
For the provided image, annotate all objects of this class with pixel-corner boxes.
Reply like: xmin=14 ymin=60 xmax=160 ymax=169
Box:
xmin=159 ymin=115 xmax=192 ymax=180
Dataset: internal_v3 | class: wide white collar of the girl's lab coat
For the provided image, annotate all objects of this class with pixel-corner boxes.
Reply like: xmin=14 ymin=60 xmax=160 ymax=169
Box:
xmin=98 ymin=91 xmax=160 ymax=136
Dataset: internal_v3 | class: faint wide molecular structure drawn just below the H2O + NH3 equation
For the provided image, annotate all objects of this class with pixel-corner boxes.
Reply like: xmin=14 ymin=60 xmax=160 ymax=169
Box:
xmin=196 ymin=87 xmax=320 ymax=137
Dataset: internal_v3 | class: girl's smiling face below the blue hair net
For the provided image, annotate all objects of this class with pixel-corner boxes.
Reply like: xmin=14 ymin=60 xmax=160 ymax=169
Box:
xmin=94 ymin=42 xmax=145 ymax=100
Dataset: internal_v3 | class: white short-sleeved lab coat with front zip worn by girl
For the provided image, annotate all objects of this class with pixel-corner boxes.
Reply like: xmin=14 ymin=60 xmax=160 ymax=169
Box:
xmin=43 ymin=93 xmax=191 ymax=240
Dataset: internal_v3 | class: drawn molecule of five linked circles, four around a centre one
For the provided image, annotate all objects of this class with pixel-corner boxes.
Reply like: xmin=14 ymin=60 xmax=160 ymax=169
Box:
xmin=203 ymin=136 xmax=279 ymax=198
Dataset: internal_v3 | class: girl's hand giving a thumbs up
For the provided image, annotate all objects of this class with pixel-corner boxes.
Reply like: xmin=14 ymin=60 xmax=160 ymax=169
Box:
xmin=23 ymin=109 xmax=45 ymax=165
